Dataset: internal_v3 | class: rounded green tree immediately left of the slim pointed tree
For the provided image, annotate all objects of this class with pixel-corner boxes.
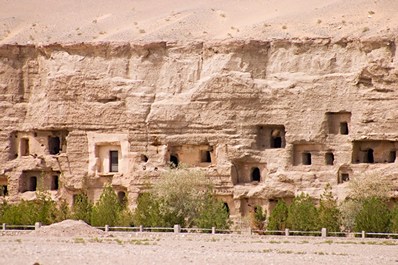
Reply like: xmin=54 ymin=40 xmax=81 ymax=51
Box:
xmin=287 ymin=193 xmax=320 ymax=231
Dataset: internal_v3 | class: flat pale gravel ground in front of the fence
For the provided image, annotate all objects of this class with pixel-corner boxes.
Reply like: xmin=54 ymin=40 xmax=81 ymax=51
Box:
xmin=0 ymin=232 xmax=398 ymax=265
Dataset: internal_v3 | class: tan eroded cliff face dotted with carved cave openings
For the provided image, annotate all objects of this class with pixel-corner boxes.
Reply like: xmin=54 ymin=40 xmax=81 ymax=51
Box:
xmin=0 ymin=38 xmax=398 ymax=219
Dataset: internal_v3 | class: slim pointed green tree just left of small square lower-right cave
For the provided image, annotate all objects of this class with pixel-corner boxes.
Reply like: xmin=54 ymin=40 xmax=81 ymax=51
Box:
xmin=318 ymin=184 xmax=340 ymax=232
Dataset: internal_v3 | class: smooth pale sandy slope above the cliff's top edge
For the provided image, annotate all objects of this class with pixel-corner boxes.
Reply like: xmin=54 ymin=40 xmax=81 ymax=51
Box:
xmin=0 ymin=0 xmax=398 ymax=44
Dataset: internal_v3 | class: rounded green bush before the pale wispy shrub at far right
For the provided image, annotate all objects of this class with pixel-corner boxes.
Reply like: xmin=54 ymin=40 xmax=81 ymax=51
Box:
xmin=354 ymin=197 xmax=390 ymax=233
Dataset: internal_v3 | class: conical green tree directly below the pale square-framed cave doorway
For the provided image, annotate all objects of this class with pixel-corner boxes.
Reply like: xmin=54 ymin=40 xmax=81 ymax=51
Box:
xmin=91 ymin=185 xmax=122 ymax=226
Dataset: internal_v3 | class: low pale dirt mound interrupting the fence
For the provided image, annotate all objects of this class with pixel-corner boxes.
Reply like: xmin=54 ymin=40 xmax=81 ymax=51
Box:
xmin=31 ymin=220 xmax=105 ymax=237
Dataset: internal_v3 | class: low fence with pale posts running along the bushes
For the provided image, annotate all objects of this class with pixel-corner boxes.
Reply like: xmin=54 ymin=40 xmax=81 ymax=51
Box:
xmin=2 ymin=223 xmax=398 ymax=239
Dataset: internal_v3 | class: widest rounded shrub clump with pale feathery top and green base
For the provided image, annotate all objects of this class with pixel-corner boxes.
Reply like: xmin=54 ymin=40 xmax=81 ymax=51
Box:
xmin=133 ymin=166 xmax=229 ymax=228
